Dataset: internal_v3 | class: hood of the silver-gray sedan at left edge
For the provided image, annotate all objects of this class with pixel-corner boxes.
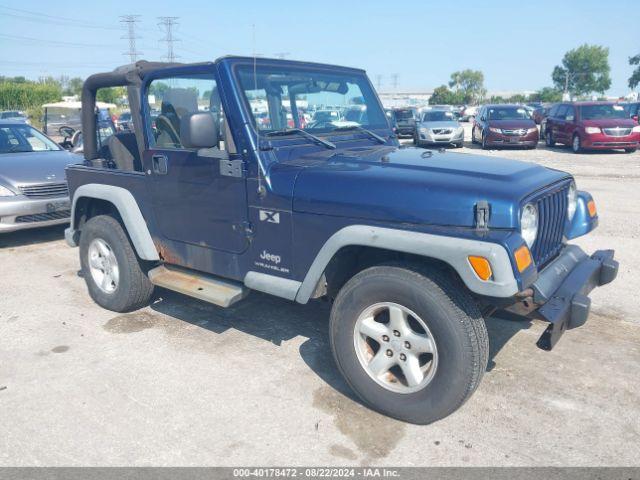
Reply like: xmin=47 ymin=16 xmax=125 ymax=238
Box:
xmin=0 ymin=150 xmax=83 ymax=190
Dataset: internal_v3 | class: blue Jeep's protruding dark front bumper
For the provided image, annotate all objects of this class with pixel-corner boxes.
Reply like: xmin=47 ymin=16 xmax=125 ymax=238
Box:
xmin=532 ymin=245 xmax=618 ymax=350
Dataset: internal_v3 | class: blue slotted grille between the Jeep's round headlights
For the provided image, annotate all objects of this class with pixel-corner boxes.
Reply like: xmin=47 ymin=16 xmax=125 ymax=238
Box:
xmin=531 ymin=183 xmax=569 ymax=269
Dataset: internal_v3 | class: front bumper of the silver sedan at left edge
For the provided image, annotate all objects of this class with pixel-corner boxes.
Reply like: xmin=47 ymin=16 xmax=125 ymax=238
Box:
xmin=0 ymin=195 xmax=71 ymax=234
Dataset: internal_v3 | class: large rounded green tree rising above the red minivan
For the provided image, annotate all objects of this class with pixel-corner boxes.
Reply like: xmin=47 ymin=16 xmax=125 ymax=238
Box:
xmin=551 ymin=43 xmax=611 ymax=96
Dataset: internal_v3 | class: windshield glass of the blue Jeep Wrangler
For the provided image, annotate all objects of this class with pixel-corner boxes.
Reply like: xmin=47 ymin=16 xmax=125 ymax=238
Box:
xmin=237 ymin=65 xmax=388 ymax=134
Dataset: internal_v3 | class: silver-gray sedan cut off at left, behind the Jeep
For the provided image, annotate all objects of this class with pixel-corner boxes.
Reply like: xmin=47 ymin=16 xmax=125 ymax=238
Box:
xmin=0 ymin=121 xmax=82 ymax=234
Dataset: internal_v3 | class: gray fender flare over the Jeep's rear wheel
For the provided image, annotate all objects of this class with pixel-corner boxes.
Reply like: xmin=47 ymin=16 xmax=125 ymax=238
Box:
xmin=65 ymin=183 xmax=160 ymax=261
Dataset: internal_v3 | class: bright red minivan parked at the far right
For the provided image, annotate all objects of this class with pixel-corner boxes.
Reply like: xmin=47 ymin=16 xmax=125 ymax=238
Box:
xmin=545 ymin=102 xmax=640 ymax=153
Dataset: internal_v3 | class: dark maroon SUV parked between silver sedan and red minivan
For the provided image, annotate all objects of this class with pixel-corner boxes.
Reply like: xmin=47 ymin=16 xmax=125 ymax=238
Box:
xmin=471 ymin=105 xmax=538 ymax=149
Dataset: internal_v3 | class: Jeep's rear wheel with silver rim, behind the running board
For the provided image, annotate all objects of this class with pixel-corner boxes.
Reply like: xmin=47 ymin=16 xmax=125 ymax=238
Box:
xmin=80 ymin=215 xmax=153 ymax=312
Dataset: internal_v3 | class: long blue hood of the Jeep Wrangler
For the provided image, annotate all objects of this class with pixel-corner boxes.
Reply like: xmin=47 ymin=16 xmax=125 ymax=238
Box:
xmin=289 ymin=147 xmax=569 ymax=228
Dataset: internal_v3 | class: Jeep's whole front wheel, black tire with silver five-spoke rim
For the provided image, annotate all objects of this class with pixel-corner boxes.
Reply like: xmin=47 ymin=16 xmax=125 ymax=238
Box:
xmin=330 ymin=265 xmax=488 ymax=424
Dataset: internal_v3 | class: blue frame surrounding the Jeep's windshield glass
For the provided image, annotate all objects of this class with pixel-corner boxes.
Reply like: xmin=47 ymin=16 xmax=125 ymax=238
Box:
xmin=232 ymin=59 xmax=391 ymax=139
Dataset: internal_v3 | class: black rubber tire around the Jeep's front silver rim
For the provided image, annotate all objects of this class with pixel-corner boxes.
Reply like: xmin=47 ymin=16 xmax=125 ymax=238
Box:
xmin=330 ymin=265 xmax=489 ymax=425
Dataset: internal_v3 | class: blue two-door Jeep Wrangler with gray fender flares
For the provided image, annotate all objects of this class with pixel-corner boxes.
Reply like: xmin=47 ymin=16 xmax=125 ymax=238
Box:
xmin=66 ymin=57 xmax=618 ymax=424
